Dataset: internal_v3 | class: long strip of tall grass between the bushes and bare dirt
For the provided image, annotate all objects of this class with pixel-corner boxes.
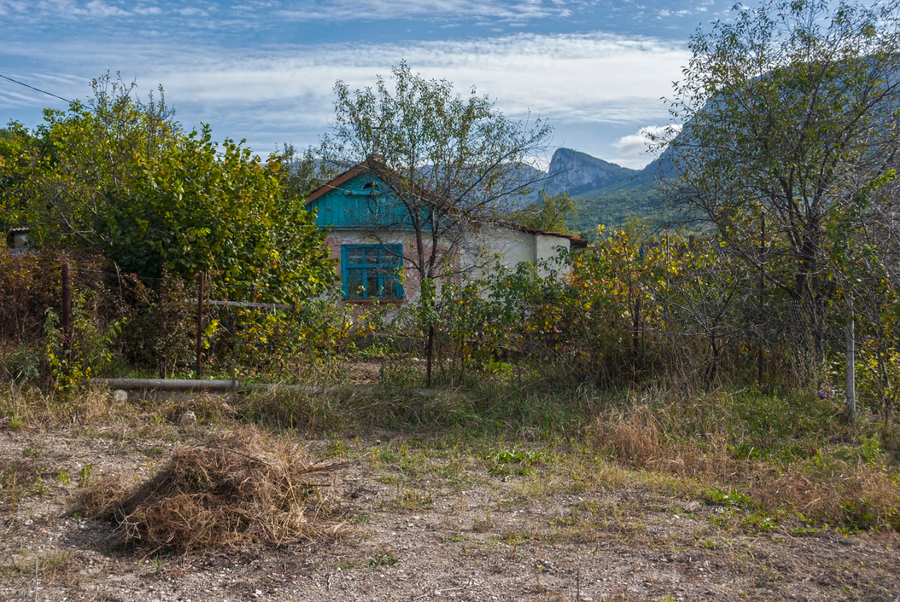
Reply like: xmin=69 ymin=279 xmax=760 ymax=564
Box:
xmin=0 ymin=378 xmax=900 ymax=529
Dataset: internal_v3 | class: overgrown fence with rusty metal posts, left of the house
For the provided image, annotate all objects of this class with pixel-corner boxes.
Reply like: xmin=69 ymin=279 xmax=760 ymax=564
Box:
xmin=0 ymin=253 xmax=358 ymax=379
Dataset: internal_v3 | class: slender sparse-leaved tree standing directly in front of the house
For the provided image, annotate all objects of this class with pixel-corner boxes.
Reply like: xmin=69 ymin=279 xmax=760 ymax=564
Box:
xmin=320 ymin=63 xmax=550 ymax=287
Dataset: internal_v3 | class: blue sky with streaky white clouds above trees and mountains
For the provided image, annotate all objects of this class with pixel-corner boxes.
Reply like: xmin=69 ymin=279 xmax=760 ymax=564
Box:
xmin=0 ymin=0 xmax=733 ymax=168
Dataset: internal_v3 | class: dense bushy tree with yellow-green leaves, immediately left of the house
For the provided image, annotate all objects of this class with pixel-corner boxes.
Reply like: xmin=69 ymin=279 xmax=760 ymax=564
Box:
xmin=97 ymin=127 xmax=334 ymax=302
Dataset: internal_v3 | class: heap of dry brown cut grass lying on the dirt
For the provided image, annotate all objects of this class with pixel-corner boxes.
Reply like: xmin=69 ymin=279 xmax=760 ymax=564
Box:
xmin=81 ymin=427 xmax=341 ymax=554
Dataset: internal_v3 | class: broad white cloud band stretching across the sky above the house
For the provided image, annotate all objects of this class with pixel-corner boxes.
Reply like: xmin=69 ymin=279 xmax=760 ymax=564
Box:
xmin=6 ymin=33 xmax=689 ymax=115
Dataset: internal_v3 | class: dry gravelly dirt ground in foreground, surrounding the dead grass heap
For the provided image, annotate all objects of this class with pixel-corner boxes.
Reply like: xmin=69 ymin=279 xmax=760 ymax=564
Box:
xmin=0 ymin=426 xmax=900 ymax=602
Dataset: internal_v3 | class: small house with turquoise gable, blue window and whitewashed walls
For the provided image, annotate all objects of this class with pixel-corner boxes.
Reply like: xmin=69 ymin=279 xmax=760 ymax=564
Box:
xmin=306 ymin=157 xmax=587 ymax=303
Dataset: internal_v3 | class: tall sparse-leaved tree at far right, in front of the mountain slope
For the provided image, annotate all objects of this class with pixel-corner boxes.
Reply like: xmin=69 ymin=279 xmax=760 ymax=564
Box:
xmin=661 ymin=0 xmax=900 ymax=363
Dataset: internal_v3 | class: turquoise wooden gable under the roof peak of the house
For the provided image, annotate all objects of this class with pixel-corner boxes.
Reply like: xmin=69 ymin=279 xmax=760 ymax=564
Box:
xmin=307 ymin=172 xmax=412 ymax=230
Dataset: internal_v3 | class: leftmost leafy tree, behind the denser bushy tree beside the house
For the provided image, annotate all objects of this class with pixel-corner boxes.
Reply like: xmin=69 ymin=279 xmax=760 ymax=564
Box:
xmin=6 ymin=75 xmax=181 ymax=251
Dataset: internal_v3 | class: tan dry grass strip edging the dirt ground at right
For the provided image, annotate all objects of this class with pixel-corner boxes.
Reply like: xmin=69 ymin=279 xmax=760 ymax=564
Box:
xmin=589 ymin=396 xmax=900 ymax=530
